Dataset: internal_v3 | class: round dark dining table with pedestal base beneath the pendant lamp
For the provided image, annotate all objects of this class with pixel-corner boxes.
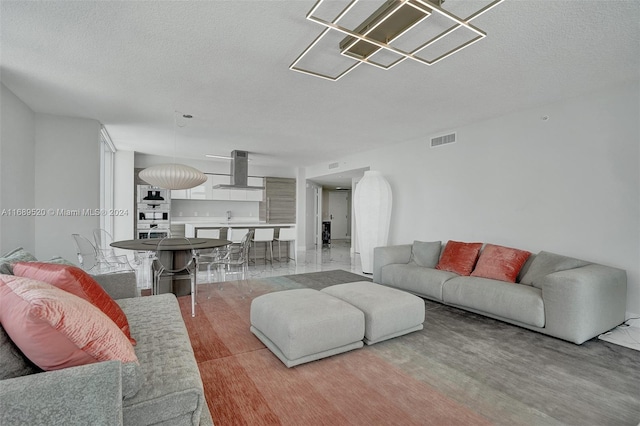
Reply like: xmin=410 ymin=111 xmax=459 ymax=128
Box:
xmin=111 ymin=237 xmax=231 ymax=296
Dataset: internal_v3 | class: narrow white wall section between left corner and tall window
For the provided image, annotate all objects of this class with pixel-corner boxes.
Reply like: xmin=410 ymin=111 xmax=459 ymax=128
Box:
xmin=35 ymin=114 xmax=100 ymax=262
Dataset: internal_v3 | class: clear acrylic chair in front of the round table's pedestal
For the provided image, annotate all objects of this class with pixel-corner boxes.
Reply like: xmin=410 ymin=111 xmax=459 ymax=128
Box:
xmin=152 ymin=237 xmax=197 ymax=317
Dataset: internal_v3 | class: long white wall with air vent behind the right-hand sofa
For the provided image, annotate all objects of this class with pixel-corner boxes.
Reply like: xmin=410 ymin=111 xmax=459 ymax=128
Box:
xmin=307 ymin=82 xmax=640 ymax=315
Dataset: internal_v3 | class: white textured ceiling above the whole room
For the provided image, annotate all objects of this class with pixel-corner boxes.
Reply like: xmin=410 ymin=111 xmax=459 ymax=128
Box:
xmin=0 ymin=0 xmax=640 ymax=175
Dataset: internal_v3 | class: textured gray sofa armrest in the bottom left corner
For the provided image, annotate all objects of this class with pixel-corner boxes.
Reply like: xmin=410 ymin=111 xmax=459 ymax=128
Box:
xmin=0 ymin=361 xmax=122 ymax=425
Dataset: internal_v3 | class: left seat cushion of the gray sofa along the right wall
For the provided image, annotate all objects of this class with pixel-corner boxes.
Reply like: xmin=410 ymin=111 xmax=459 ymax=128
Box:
xmin=380 ymin=263 xmax=458 ymax=300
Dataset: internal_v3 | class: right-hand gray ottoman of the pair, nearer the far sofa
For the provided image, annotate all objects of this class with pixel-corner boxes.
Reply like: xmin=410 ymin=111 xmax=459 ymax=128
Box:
xmin=322 ymin=281 xmax=424 ymax=345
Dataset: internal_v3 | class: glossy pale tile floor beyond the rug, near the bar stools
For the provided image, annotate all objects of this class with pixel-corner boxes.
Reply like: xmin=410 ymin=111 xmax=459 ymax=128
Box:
xmin=198 ymin=240 xmax=364 ymax=283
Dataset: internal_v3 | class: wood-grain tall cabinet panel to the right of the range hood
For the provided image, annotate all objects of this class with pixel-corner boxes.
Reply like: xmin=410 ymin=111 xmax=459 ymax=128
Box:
xmin=259 ymin=177 xmax=296 ymax=223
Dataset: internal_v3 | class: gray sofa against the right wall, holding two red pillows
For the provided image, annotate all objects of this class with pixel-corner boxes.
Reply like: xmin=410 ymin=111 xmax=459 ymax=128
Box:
xmin=373 ymin=241 xmax=627 ymax=344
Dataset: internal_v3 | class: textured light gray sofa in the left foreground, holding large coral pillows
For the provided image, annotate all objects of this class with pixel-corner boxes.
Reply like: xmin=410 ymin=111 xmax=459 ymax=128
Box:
xmin=0 ymin=273 xmax=213 ymax=426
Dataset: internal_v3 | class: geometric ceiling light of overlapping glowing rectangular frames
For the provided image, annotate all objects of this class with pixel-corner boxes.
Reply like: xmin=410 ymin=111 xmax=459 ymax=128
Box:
xmin=289 ymin=0 xmax=504 ymax=81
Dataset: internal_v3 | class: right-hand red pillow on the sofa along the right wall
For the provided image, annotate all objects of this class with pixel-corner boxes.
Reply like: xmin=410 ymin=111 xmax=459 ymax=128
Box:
xmin=471 ymin=244 xmax=531 ymax=283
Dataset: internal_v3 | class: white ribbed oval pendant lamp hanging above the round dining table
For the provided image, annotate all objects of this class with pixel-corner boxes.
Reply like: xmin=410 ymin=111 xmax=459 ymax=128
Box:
xmin=139 ymin=111 xmax=207 ymax=189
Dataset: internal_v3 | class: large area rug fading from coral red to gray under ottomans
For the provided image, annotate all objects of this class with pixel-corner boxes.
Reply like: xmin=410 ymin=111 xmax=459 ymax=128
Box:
xmin=179 ymin=271 xmax=640 ymax=425
